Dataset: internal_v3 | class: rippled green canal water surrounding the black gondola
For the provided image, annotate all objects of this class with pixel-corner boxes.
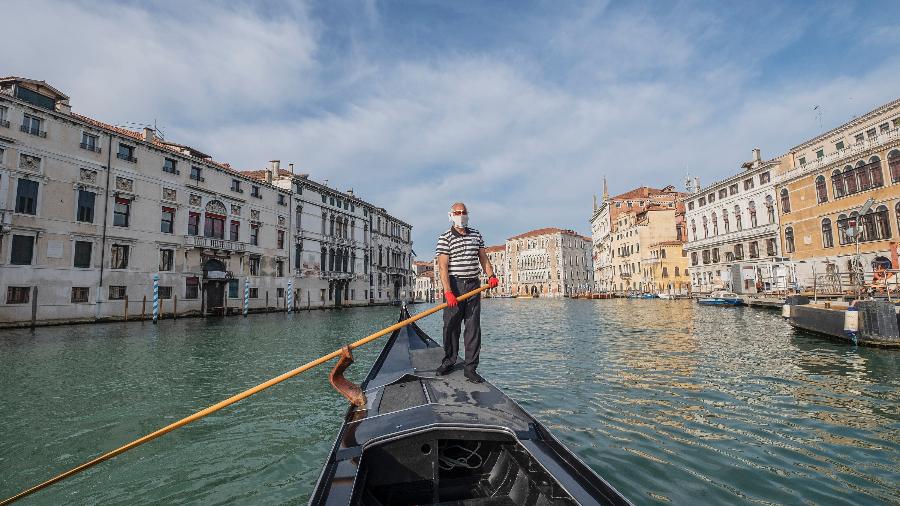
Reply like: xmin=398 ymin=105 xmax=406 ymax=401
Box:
xmin=0 ymin=299 xmax=900 ymax=505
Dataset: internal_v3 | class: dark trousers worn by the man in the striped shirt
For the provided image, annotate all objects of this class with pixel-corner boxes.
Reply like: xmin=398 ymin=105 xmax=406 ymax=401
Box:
xmin=442 ymin=276 xmax=481 ymax=371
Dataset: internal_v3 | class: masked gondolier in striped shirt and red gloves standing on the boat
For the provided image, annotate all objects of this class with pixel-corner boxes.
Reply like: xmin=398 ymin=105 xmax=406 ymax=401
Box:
xmin=435 ymin=202 xmax=498 ymax=383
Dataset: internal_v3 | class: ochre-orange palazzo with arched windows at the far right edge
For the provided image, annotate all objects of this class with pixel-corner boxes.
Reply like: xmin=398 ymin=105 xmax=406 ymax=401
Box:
xmin=776 ymin=100 xmax=900 ymax=287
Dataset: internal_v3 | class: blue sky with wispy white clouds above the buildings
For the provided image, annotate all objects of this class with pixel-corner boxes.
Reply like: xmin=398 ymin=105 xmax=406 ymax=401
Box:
xmin=7 ymin=0 xmax=900 ymax=253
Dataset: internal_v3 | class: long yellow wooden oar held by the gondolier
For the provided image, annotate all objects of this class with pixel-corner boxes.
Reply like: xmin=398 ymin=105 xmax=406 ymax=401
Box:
xmin=0 ymin=285 xmax=489 ymax=506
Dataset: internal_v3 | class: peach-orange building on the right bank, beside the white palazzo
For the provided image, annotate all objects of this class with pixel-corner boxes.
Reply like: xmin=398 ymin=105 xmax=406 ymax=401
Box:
xmin=607 ymin=205 xmax=683 ymax=294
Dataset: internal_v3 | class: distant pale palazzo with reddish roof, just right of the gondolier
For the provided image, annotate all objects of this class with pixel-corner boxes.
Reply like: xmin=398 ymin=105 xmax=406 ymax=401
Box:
xmin=504 ymin=228 xmax=594 ymax=297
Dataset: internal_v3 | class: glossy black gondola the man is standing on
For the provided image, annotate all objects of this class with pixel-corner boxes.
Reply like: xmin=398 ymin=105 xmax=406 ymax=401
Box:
xmin=309 ymin=307 xmax=631 ymax=506
